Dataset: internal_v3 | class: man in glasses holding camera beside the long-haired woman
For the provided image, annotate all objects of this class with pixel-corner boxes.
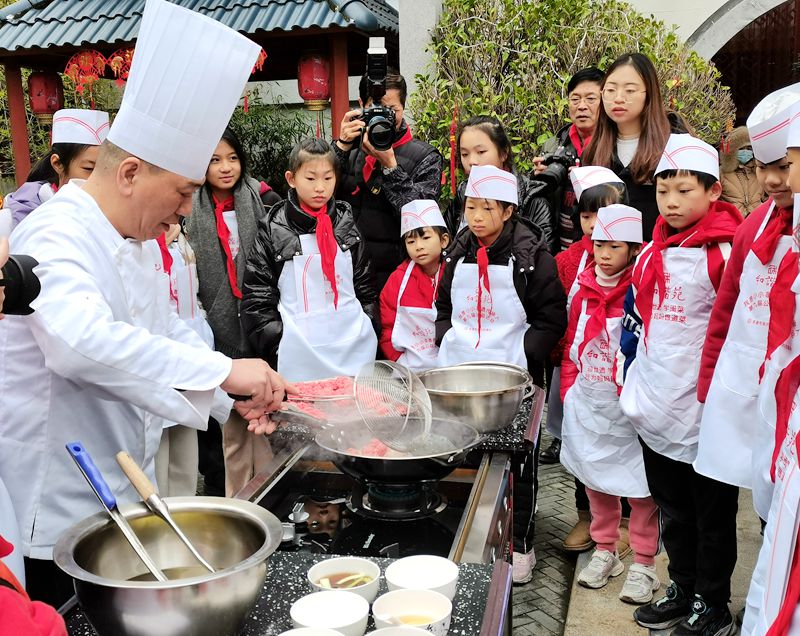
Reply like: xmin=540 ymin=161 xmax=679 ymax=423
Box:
xmin=533 ymin=66 xmax=603 ymax=251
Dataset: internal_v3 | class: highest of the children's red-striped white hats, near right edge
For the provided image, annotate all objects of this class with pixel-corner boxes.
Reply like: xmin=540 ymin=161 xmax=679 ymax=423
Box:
xmin=747 ymin=83 xmax=800 ymax=163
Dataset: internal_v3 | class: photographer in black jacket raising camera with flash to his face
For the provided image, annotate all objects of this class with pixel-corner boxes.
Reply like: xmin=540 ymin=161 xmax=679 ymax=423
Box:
xmin=334 ymin=38 xmax=442 ymax=290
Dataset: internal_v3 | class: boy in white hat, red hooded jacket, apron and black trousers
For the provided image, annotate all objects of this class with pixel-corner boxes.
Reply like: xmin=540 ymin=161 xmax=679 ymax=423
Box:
xmin=618 ymin=134 xmax=742 ymax=635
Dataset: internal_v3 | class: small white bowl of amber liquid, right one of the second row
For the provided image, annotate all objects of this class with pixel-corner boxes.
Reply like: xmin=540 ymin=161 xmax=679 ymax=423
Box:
xmin=372 ymin=590 xmax=453 ymax=636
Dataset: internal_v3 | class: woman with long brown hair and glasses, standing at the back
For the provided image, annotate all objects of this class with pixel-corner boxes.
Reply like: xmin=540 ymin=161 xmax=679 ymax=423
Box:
xmin=581 ymin=53 xmax=686 ymax=241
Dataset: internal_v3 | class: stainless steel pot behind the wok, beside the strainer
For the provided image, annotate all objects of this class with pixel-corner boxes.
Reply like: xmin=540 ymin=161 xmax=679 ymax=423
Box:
xmin=419 ymin=362 xmax=533 ymax=433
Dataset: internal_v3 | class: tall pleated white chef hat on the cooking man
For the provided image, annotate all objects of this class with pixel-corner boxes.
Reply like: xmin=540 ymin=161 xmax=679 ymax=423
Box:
xmin=108 ymin=0 xmax=261 ymax=180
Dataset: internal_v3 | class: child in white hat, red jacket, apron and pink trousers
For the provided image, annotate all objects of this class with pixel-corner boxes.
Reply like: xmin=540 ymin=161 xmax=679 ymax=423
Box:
xmin=561 ymin=204 xmax=660 ymax=603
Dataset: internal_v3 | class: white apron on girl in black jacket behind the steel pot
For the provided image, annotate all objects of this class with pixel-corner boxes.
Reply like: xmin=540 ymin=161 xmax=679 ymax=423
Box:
xmin=438 ymin=258 xmax=530 ymax=369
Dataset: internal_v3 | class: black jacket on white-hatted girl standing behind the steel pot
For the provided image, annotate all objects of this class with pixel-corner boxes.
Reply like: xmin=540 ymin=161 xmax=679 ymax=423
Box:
xmin=436 ymin=216 xmax=567 ymax=386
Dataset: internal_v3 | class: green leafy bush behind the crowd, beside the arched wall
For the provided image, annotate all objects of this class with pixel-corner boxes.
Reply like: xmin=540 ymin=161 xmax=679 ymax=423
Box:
xmin=410 ymin=0 xmax=734 ymax=186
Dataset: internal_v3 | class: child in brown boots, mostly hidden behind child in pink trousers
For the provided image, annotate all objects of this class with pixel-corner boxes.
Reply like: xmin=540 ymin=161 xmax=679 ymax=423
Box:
xmin=539 ymin=166 xmax=630 ymax=557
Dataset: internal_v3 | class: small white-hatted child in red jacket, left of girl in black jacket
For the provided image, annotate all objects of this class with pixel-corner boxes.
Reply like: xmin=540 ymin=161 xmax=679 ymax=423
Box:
xmin=380 ymin=199 xmax=450 ymax=371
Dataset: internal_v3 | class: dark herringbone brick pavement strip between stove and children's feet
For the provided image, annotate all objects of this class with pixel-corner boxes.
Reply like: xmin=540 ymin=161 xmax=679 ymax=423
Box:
xmin=512 ymin=433 xmax=578 ymax=636
